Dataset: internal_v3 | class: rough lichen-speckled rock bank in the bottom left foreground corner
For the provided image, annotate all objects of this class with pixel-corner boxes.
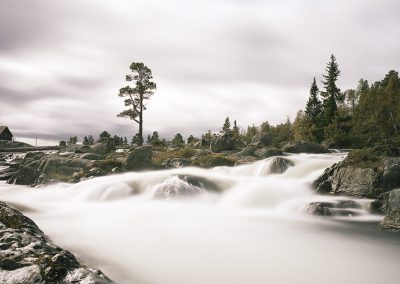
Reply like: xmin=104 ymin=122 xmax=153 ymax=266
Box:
xmin=0 ymin=202 xmax=113 ymax=284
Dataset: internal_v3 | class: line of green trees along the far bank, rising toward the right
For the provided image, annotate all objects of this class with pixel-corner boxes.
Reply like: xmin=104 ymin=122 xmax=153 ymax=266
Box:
xmin=69 ymin=55 xmax=400 ymax=148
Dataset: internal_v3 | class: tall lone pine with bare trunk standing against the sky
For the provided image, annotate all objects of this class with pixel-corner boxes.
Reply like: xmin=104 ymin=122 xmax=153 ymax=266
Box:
xmin=118 ymin=62 xmax=156 ymax=146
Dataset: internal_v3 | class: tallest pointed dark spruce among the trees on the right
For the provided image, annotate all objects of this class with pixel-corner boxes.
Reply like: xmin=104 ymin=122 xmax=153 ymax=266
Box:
xmin=321 ymin=54 xmax=343 ymax=125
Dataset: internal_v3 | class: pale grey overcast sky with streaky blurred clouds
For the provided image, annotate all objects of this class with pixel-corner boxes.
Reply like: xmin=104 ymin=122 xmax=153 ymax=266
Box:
xmin=0 ymin=0 xmax=400 ymax=144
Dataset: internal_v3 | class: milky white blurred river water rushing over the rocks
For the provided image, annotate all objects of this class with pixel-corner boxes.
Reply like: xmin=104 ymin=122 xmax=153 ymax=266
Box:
xmin=0 ymin=153 xmax=400 ymax=284
